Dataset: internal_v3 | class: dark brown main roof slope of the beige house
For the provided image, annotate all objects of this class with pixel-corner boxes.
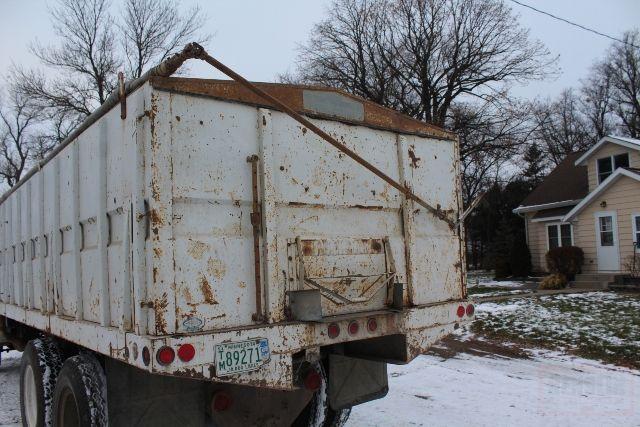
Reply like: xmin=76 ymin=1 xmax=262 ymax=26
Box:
xmin=514 ymin=152 xmax=589 ymax=213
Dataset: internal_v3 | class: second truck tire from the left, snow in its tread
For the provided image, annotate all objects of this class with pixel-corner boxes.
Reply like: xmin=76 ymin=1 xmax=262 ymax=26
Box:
xmin=53 ymin=353 xmax=108 ymax=427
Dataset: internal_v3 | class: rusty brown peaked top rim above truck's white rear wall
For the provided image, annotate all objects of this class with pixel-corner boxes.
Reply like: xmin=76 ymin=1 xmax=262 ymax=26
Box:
xmin=150 ymin=77 xmax=457 ymax=141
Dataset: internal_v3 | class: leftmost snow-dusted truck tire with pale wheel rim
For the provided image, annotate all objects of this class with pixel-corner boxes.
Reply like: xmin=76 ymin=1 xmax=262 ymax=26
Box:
xmin=20 ymin=338 xmax=62 ymax=427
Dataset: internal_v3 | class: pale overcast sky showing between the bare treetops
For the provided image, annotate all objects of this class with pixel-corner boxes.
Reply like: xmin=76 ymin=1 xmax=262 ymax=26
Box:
xmin=0 ymin=0 xmax=640 ymax=98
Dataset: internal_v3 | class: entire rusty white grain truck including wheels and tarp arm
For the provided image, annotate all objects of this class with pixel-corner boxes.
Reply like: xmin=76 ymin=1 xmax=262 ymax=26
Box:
xmin=0 ymin=44 xmax=473 ymax=427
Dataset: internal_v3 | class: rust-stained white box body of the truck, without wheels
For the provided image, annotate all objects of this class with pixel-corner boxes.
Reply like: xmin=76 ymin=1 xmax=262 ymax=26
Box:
xmin=0 ymin=78 xmax=468 ymax=389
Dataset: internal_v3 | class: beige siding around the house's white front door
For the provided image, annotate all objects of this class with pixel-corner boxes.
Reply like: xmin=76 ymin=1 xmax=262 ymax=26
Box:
xmin=572 ymin=175 xmax=640 ymax=273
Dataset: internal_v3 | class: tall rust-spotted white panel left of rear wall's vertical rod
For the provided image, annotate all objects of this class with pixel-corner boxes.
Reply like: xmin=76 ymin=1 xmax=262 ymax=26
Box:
xmin=168 ymin=93 xmax=259 ymax=332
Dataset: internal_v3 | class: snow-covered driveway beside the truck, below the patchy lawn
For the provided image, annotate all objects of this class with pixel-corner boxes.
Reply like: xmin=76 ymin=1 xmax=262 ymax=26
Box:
xmin=347 ymin=351 xmax=640 ymax=427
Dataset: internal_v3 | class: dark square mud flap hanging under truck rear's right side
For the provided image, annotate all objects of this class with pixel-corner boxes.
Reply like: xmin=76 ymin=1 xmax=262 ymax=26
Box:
xmin=329 ymin=354 xmax=389 ymax=411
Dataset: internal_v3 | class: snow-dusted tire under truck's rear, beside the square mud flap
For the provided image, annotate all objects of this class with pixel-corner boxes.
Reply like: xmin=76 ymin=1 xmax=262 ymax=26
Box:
xmin=293 ymin=363 xmax=351 ymax=427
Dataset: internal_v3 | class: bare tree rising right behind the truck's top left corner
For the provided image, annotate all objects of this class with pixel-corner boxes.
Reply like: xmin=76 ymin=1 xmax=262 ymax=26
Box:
xmin=119 ymin=0 xmax=209 ymax=78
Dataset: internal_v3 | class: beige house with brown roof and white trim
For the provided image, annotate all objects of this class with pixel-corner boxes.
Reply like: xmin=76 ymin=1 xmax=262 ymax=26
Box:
xmin=514 ymin=136 xmax=640 ymax=274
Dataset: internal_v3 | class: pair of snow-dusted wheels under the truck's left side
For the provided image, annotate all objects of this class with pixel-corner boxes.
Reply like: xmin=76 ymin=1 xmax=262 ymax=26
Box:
xmin=20 ymin=338 xmax=107 ymax=427
